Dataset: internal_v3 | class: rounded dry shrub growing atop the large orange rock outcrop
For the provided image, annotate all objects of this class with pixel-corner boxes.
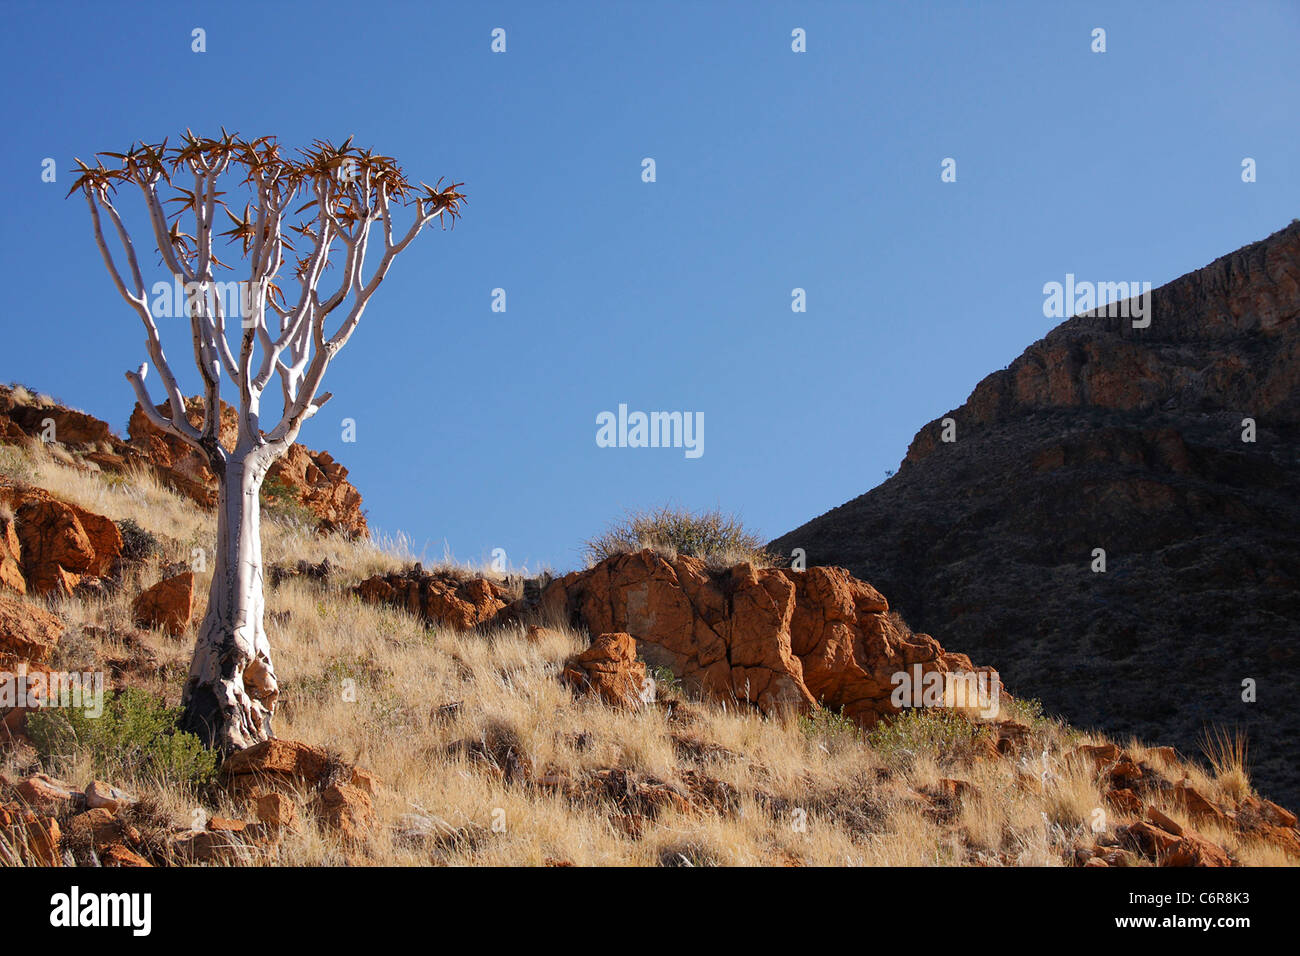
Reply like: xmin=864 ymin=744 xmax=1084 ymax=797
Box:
xmin=582 ymin=506 xmax=776 ymax=567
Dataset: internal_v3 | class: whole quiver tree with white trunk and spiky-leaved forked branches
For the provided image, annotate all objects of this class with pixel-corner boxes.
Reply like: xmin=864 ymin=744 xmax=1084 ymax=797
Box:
xmin=69 ymin=130 xmax=464 ymax=752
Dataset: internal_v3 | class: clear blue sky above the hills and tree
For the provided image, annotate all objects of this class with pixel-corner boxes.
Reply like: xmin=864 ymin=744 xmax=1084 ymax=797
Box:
xmin=0 ymin=0 xmax=1300 ymax=568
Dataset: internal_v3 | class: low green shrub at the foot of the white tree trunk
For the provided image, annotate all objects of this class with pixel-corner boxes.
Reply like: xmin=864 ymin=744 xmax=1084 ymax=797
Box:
xmin=27 ymin=688 xmax=217 ymax=787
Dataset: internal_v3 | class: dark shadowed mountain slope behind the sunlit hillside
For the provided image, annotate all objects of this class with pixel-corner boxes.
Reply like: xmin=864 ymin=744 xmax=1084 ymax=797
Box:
xmin=770 ymin=224 xmax=1300 ymax=803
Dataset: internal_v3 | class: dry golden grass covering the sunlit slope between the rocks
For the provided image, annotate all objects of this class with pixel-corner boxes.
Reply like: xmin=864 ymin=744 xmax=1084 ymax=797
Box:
xmin=3 ymin=447 xmax=1295 ymax=866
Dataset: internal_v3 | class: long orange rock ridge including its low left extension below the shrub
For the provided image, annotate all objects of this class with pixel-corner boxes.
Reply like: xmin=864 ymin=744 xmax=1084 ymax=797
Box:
xmin=355 ymin=549 xmax=1002 ymax=726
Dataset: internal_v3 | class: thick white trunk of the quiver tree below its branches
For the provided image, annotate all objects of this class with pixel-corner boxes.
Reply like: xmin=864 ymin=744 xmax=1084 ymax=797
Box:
xmin=182 ymin=447 xmax=280 ymax=753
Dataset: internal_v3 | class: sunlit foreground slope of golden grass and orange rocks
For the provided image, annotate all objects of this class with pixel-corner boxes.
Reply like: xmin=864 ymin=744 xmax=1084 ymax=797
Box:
xmin=0 ymin=411 xmax=1300 ymax=868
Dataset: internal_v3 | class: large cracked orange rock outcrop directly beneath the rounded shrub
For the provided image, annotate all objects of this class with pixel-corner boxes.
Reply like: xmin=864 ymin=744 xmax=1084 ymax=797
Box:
xmin=542 ymin=550 xmax=996 ymax=724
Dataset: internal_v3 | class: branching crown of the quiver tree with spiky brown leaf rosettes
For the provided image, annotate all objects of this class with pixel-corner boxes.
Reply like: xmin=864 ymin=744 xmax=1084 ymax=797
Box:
xmin=68 ymin=129 xmax=467 ymax=460
